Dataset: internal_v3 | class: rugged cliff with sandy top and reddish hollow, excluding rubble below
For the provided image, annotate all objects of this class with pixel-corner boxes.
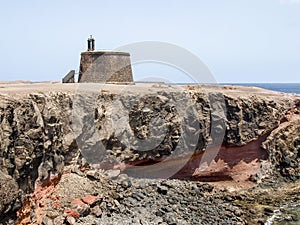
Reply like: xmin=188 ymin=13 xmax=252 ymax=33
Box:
xmin=0 ymin=84 xmax=300 ymax=224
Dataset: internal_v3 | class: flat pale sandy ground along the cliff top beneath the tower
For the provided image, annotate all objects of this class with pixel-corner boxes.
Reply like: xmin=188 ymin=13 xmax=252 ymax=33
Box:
xmin=0 ymin=81 xmax=295 ymax=96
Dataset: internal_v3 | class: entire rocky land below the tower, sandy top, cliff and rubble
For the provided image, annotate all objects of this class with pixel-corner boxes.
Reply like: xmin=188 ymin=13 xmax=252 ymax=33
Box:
xmin=0 ymin=82 xmax=300 ymax=225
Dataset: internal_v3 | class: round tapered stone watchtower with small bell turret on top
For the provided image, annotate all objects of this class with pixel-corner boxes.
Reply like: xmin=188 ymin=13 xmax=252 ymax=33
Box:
xmin=78 ymin=35 xmax=133 ymax=84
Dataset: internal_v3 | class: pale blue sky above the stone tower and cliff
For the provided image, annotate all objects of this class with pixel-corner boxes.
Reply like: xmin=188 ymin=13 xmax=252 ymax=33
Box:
xmin=0 ymin=0 xmax=300 ymax=83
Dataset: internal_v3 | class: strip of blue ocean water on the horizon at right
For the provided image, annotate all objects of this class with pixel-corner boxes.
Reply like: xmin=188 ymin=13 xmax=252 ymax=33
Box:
xmin=221 ymin=83 xmax=300 ymax=94
